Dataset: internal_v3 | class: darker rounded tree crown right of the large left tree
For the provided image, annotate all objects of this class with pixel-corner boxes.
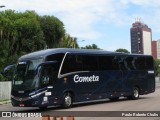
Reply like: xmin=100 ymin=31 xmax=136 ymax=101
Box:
xmin=40 ymin=16 xmax=65 ymax=48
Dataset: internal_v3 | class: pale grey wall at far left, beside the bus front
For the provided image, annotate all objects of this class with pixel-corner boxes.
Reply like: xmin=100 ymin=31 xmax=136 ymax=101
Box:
xmin=0 ymin=81 xmax=11 ymax=101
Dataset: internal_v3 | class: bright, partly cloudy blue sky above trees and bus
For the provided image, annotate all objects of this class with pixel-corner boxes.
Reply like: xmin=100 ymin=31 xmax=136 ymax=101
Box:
xmin=0 ymin=0 xmax=160 ymax=51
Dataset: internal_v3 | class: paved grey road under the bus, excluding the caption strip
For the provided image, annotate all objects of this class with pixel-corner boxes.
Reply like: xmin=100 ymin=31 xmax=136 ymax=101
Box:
xmin=0 ymin=87 xmax=160 ymax=120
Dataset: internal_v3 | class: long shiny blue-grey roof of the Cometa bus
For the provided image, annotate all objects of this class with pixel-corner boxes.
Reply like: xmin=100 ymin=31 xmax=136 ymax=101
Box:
xmin=19 ymin=48 xmax=151 ymax=60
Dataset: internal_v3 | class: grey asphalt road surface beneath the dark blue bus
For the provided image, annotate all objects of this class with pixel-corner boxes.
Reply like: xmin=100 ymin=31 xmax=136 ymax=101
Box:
xmin=0 ymin=84 xmax=160 ymax=120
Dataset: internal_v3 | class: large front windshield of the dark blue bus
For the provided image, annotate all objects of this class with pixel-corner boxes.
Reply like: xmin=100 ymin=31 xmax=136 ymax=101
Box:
xmin=12 ymin=59 xmax=43 ymax=90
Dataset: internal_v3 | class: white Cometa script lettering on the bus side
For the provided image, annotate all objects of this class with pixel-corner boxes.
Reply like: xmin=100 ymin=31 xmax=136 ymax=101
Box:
xmin=74 ymin=75 xmax=99 ymax=83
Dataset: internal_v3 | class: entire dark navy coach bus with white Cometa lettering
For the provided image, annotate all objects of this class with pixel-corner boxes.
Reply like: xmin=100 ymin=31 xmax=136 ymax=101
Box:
xmin=11 ymin=48 xmax=155 ymax=108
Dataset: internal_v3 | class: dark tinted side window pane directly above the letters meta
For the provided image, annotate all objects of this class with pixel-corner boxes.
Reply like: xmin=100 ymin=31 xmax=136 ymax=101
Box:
xmin=82 ymin=55 xmax=98 ymax=71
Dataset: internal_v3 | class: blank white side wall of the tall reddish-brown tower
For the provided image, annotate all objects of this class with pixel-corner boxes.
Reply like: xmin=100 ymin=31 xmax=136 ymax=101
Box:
xmin=143 ymin=31 xmax=152 ymax=55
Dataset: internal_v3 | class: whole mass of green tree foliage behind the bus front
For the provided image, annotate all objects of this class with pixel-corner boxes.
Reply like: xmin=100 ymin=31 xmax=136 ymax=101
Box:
xmin=0 ymin=10 xmax=72 ymax=78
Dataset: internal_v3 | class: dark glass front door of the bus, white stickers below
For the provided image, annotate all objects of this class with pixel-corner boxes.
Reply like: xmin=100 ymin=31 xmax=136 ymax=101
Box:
xmin=37 ymin=62 xmax=59 ymax=104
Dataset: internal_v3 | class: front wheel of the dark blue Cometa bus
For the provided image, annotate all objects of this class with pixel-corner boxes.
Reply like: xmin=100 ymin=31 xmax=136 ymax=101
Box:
xmin=63 ymin=93 xmax=72 ymax=108
